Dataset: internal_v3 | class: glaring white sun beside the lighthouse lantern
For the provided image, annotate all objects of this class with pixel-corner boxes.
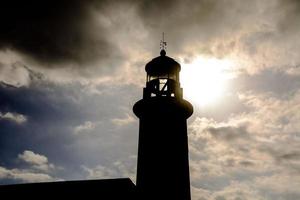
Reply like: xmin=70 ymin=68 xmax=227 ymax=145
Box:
xmin=180 ymin=57 xmax=233 ymax=106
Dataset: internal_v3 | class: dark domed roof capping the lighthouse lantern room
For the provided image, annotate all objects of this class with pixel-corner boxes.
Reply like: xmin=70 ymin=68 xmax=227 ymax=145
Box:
xmin=145 ymin=50 xmax=181 ymax=76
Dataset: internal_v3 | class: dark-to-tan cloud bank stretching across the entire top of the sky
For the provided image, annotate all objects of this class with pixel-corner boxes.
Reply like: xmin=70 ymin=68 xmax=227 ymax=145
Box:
xmin=0 ymin=0 xmax=300 ymax=81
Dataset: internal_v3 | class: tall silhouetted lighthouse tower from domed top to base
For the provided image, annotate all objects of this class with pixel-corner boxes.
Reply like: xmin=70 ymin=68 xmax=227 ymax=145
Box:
xmin=133 ymin=48 xmax=193 ymax=200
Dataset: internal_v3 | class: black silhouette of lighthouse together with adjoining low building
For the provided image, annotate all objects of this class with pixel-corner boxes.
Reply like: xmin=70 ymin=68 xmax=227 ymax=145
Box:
xmin=0 ymin=48 xmax=193 ymax=200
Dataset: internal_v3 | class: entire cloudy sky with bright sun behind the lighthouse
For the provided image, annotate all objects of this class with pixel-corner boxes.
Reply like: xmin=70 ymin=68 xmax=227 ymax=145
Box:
xmin=0 ymin=0 xmax=300 ymax=200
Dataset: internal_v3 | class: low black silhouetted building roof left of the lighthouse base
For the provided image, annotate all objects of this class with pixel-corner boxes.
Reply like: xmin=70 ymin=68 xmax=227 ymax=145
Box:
xmin=0 ymin=178 xmax=136 ymax=200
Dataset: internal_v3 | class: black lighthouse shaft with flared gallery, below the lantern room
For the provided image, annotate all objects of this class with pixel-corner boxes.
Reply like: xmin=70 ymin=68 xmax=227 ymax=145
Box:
xmin=134 ymin=98 xmax=192 ymax=200
